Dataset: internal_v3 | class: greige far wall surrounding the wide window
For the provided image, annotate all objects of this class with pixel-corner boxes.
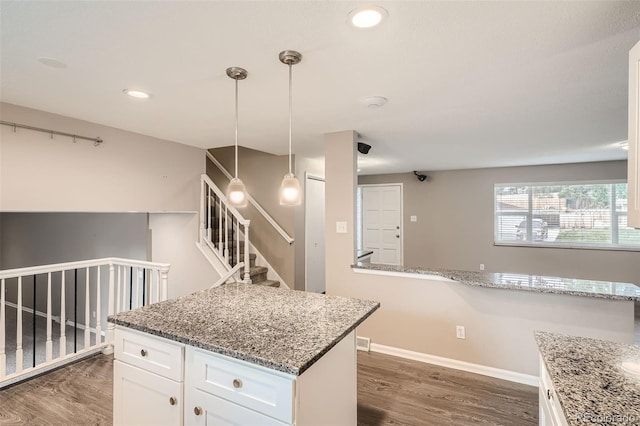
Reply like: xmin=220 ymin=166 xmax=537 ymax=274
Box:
xmin=358 ymin=161 xmax=640 ymax=283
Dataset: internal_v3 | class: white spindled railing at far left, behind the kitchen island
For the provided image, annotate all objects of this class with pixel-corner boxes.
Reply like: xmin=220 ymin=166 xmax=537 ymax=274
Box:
xmin=0 ymin=258 xmax=169 ymax=388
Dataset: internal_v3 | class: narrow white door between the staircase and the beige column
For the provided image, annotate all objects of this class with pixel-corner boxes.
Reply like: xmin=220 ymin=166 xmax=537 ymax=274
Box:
xmin=304 ymin=174 xmax=326 ymax=293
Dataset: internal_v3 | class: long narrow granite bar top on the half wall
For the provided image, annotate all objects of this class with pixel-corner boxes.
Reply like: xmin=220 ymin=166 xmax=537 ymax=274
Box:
xmin=352 ymin=263 xmax=640 ymax=301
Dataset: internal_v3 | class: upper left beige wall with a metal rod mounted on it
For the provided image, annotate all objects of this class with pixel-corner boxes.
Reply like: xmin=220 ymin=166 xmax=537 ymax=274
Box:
xmin=0 ymin=103 xmax=205 ymax=212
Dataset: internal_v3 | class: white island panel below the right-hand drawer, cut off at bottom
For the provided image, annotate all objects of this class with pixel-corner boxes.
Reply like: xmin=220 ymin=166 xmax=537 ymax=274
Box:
xmin=184 ymin=387 xmax=287 ymax=426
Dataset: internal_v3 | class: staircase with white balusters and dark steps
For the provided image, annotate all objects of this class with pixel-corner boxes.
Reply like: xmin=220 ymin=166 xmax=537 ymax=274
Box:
xmin=198 ymin=175 xmax=280 ymax=287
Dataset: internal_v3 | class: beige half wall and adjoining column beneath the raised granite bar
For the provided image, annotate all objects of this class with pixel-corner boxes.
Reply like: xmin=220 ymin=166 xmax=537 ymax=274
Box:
xmin=325 ymin=131 xmax=633 ymax=375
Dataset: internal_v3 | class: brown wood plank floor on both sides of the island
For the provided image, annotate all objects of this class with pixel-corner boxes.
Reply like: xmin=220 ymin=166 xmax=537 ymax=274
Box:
xmin=0 ymin=352 xmax=538 ymax=426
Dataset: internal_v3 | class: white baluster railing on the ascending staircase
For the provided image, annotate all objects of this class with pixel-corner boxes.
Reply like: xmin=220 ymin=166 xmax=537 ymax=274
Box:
xmin=199 ymin=174 xmax=251 ymax=284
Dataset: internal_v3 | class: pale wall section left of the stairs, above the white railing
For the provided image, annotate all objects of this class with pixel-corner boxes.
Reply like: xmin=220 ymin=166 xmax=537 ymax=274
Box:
xmin=149 ymin=213 xmax=220 ymax=299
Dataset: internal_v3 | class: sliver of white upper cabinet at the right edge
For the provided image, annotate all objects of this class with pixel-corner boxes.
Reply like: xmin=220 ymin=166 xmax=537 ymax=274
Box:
xmin=627 ymin=42 xmax=640 ymax=228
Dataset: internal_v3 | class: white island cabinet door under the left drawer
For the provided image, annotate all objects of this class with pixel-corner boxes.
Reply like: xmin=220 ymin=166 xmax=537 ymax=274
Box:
xmin=113 ymin=360 xmax=184 ymax=426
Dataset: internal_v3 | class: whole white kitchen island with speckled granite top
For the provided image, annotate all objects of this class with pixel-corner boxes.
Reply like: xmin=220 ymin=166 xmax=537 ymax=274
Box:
xmin=109 ymin=284 xmax=380 ymax=425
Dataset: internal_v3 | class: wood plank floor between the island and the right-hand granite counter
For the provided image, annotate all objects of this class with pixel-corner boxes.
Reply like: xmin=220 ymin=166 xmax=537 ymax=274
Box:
xmin=358 ymin=352 xmax=538 ymax=426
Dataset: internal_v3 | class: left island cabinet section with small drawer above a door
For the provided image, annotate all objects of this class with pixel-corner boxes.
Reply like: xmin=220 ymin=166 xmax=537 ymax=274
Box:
xmin=113 ymin=327 xmax=184 ymax=426
